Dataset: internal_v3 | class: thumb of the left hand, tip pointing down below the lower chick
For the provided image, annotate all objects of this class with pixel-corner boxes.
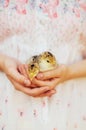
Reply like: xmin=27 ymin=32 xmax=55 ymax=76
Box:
xmin=7 ymin=68 xmax=31 ymax=86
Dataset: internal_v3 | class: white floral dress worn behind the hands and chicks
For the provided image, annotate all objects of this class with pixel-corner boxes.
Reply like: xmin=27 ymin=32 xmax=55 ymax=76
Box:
xmin=0 ymin=0 xmax=86 ymax=130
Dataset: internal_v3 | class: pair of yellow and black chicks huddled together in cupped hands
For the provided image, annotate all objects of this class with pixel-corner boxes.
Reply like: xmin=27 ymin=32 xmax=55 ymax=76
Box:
xmin=27 ymin=51 xmax=57 ymax=80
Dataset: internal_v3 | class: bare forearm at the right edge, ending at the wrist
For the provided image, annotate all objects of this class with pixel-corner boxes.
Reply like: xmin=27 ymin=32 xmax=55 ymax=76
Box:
xmin=68 ymin=60 xmax=86 ymax=79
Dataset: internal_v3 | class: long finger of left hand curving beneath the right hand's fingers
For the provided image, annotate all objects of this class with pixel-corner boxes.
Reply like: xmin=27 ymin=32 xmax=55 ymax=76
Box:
xmin=11 ymin=79 xmax=49 ymax=97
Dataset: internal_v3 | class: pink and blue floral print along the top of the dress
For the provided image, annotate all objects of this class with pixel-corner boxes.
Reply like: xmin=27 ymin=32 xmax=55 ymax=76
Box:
xmin=0 ymin=0 xmax=86 ymax=19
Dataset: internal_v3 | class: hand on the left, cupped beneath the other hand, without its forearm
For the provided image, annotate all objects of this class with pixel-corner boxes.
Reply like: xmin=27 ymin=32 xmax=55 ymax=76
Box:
xmin=2 ymin=56 xmax=48 ymax=97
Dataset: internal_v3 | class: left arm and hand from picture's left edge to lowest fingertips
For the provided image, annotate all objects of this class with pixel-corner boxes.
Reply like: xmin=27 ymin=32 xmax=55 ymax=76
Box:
xmin=0 ymin=54 xmax=54 ymax=97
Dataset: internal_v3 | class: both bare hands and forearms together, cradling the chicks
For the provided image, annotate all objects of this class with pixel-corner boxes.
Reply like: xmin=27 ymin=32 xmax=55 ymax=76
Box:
xmin=0 ymin=43 xmax=86 ymax=97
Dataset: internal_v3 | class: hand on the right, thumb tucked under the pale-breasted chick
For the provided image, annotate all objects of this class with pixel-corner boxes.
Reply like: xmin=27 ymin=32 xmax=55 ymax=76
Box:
xmin=33 ymin=65 xmax=69 ymax=90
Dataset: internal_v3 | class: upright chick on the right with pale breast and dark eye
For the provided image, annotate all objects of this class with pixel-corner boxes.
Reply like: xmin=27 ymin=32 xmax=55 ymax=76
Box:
xmin=38 ymin=51 xmax=57 ymax=72
